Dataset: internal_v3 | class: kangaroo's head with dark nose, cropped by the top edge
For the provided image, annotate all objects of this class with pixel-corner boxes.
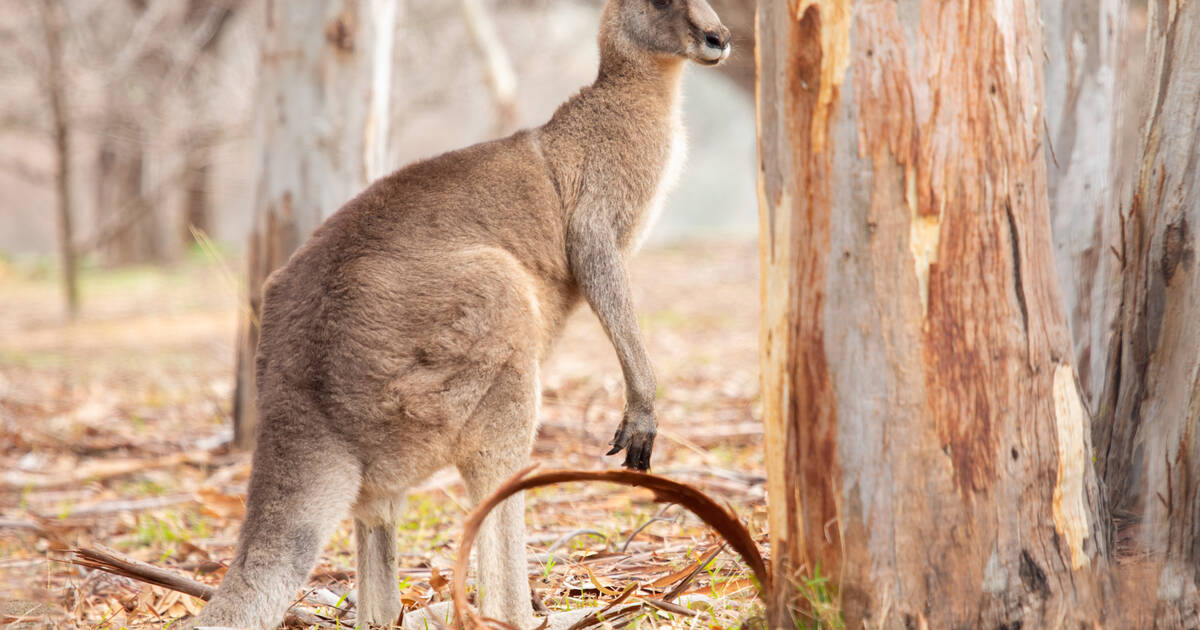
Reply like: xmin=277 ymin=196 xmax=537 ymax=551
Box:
xmin=601 ymin=0 xmax=731 ymax=66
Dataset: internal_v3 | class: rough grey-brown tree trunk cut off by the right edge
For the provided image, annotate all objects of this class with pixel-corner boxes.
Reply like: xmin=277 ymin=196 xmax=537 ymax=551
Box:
xmin=1096 ymin=0 xmax=1200 ymax=628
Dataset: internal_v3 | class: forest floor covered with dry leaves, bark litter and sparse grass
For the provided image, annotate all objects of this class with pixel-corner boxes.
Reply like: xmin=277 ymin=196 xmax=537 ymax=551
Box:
xmin=0 ymin=242 xmax=767 ymax=629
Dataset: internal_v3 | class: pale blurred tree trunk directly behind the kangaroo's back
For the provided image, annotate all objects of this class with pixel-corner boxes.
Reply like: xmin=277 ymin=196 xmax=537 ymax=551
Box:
xmin=234 ymin=0 xmax=398 ymax=449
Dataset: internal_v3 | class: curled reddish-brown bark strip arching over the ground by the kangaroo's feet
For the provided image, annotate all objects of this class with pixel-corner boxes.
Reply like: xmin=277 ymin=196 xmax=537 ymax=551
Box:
xmin=454 ymin=466 xmax=770 ymax=629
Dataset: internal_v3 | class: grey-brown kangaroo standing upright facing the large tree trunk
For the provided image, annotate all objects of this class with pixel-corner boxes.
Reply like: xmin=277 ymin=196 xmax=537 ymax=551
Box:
xmin=197 ymin=0 xmax=731 ymax=629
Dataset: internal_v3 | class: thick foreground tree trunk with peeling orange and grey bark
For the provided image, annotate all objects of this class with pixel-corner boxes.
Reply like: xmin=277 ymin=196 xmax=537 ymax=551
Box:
xmin=757 ymin=0 xmax=1109 ymax=628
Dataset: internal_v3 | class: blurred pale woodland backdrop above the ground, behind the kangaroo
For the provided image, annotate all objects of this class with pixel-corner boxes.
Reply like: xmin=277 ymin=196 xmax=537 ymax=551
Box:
xmin=0 ymin=0 xmax=757 ymax=266
